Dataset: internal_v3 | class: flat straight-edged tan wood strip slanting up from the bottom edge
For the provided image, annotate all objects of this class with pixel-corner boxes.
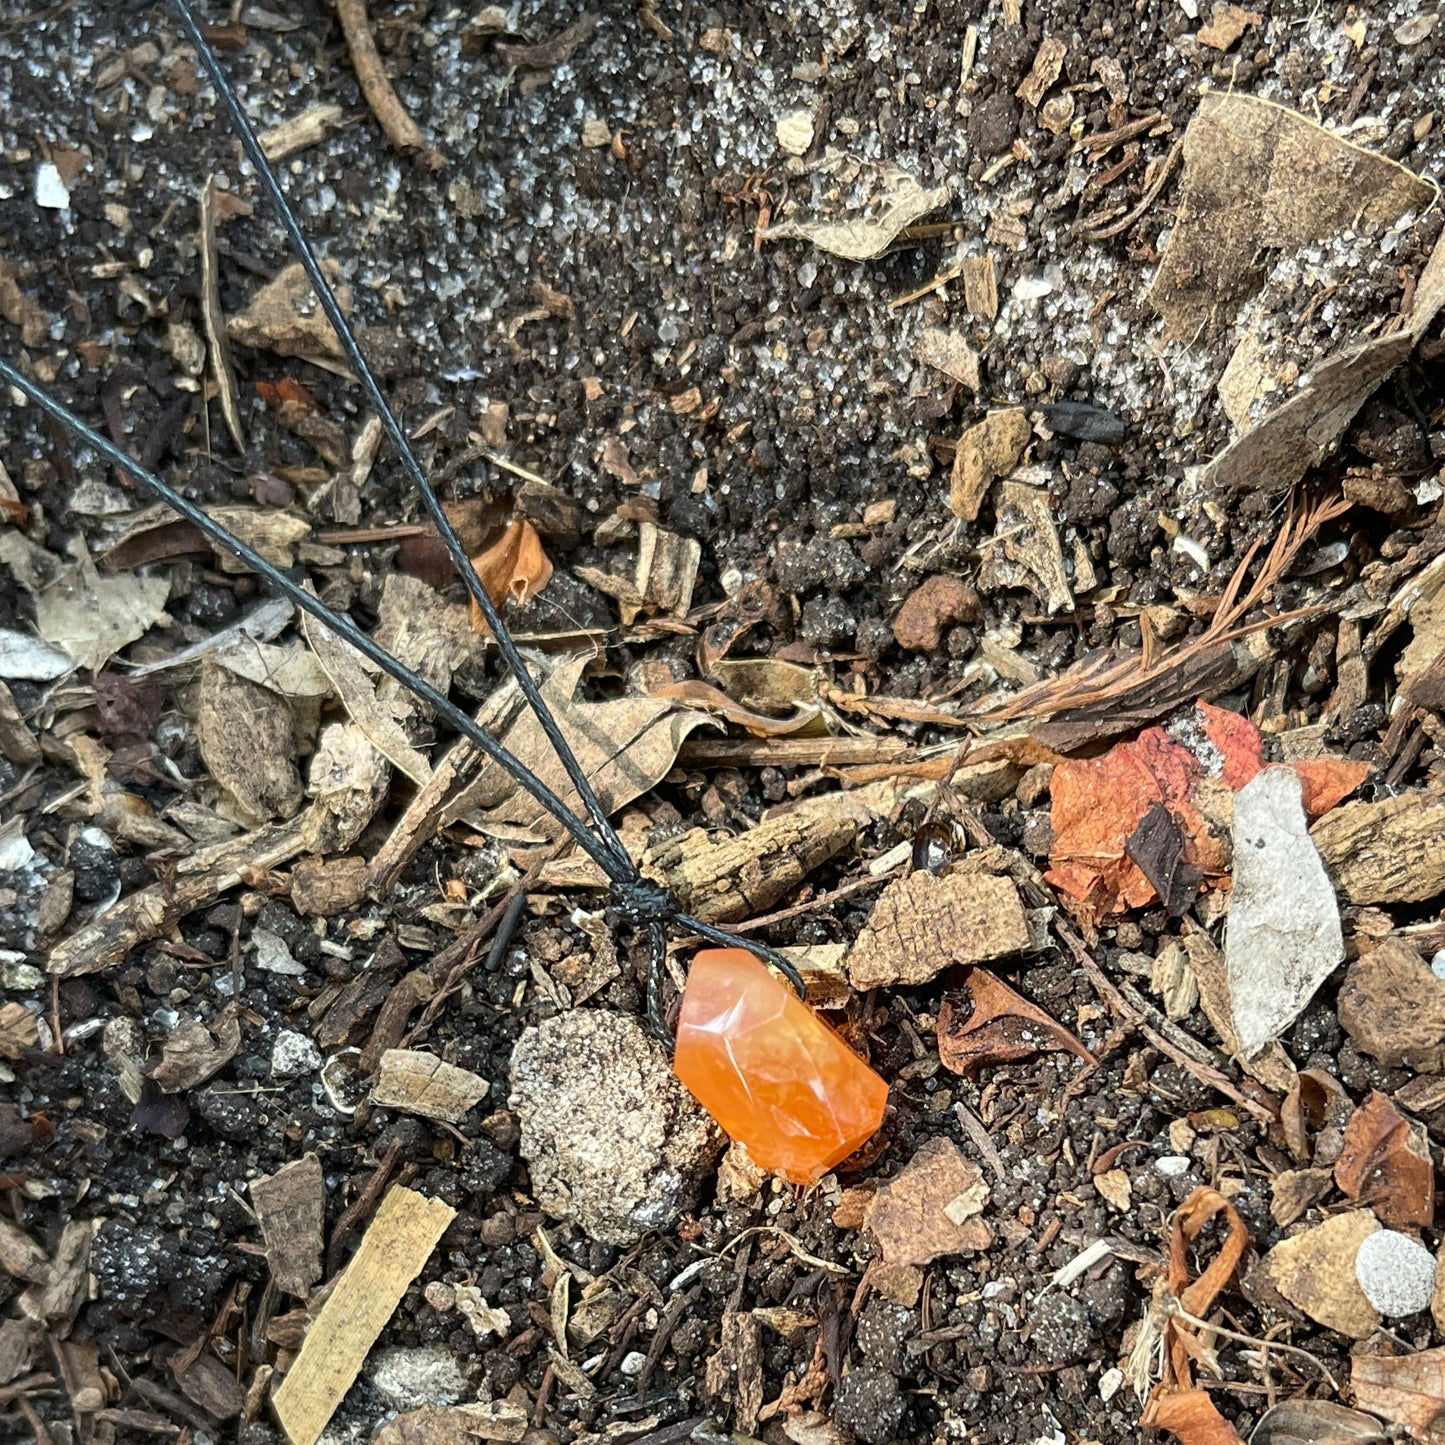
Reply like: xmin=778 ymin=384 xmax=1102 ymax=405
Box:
xmin=272 ymin=1185 xmax=457 ymax=1445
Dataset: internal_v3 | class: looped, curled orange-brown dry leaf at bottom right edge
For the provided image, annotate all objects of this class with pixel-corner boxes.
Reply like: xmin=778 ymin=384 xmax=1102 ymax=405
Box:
xmin=1142 ymin=1188 xmax=1250 ymax=1445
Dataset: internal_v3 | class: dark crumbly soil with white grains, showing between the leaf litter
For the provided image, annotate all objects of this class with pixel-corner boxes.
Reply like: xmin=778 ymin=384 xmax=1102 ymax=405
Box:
xmin=8 ymin=0 xmax=1445 ymax=1445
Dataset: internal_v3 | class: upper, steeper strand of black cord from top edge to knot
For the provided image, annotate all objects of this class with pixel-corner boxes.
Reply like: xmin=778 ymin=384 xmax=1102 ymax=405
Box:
xmin=173 ymin=0 xmax=637 ymax=879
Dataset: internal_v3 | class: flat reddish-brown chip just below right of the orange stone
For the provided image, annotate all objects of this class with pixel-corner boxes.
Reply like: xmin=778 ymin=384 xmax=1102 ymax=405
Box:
xmin=867 ymin=1137 xmax=993 ymax=1264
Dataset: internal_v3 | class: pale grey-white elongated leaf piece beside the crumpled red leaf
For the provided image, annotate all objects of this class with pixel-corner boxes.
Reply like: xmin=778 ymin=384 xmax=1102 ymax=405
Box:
xmin=1224 ymin=767 xmax=1345 ymax=1058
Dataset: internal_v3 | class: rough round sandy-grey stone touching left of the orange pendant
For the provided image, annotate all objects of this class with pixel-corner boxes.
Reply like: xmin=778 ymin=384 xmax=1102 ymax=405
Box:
xmin=507 ymin=1009 xmax=723 ymax=1244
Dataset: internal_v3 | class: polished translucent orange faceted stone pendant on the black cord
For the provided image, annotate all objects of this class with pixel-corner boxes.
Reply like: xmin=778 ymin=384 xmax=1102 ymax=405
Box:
xmin=672 ymin=948 xmax=889 ymax=1183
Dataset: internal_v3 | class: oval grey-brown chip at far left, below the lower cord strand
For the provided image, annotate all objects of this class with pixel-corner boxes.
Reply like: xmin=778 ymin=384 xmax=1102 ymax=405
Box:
xmin=197 ymin=658 xmax=305 ymax=821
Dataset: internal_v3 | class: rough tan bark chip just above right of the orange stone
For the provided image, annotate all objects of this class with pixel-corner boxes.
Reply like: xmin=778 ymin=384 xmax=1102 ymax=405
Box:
xmin=844 ymin=873 xmax=1029 ymax=990
